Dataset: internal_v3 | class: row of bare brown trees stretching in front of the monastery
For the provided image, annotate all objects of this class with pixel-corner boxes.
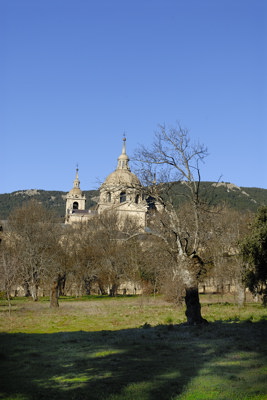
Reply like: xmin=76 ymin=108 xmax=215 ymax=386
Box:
xmin=0 ymin=199 xmax=260 ymax=306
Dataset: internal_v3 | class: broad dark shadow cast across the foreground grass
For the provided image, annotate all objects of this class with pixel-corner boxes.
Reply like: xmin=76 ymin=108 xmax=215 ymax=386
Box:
xmin=0 ymin=321 xmax=267 ymax=400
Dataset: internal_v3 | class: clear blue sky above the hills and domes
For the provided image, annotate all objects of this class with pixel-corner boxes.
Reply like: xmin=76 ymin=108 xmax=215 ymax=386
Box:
xmin=0 ymin=0 xmax=267 ymax=193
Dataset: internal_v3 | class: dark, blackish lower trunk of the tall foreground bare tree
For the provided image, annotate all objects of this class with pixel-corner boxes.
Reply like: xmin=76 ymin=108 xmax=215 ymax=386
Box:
xmin=185 ymin=286 xmax=208 ymax=325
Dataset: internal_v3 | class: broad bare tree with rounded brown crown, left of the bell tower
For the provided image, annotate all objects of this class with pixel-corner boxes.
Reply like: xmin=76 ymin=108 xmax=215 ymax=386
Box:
xmin=8 ymin=200 xmax=59 ymax=301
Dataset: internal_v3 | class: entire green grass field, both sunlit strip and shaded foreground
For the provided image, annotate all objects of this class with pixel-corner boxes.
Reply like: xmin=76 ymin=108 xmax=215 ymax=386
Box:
xmin=0 ymin=295 xmax=267 ymax=400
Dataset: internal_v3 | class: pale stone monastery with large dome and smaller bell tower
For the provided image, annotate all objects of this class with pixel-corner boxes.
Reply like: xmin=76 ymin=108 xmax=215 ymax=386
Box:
xmin=65 ymin=137 xmax=148 ymax=228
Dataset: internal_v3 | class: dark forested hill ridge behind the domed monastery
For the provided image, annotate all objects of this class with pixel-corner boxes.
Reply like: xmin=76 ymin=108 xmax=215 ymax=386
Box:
xmin=0 ymin=182 xmax=267 ymax=220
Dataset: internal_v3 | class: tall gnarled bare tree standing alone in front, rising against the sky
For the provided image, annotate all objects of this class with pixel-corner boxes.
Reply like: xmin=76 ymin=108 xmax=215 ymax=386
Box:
xmin=135 ymin=125 xmax=210 ymax=324
